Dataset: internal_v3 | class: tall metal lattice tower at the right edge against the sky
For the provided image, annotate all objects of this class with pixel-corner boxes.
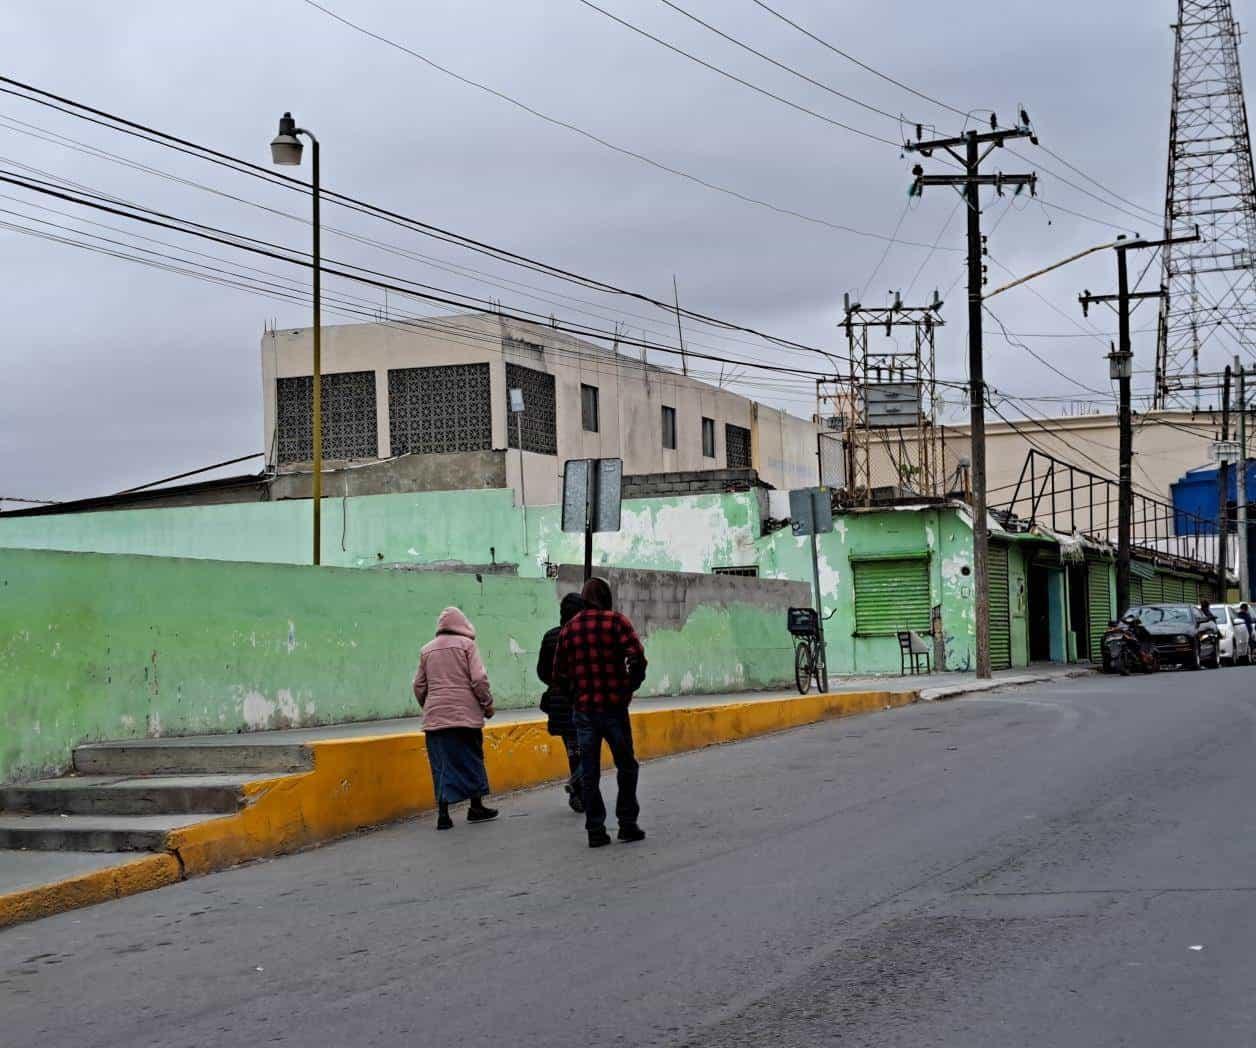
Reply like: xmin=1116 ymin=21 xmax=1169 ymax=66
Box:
xmin=1156 ymin=0 xmax=1256 ymax=407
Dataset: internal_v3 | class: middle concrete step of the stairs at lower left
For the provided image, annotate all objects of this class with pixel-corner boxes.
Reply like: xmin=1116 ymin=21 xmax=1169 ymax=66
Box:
xmin=0 ymin=774 xmax=256 ymax=816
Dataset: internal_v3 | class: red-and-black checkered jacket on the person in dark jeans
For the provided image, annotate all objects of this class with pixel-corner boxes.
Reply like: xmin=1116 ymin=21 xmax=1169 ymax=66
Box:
xmin=554 ymin=608 xmax=646 ymax=712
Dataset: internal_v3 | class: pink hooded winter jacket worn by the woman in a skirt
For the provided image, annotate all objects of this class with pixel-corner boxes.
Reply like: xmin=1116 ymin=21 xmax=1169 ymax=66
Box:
xmin=414 ymin=608 xmax=492 ymax=731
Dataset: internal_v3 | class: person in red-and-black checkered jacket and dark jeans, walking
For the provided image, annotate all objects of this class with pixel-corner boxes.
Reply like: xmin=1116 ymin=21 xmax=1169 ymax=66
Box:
xmin=554 ymin=578 xmax=647 ymax=848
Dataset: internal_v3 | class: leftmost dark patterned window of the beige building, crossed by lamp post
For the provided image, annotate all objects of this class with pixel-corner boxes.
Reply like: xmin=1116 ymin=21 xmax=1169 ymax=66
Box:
xmin=282 ymin=371 xmax=379 ymax=462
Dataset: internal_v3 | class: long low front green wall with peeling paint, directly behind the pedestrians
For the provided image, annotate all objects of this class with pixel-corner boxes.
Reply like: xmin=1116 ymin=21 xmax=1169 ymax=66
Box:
xmin=0 ymin=550 xmax=793 ymax=782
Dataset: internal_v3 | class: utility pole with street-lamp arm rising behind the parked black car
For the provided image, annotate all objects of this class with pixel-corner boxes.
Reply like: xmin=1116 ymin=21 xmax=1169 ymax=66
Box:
xmin=1078 ymin=230 xmax=1199 ymax=614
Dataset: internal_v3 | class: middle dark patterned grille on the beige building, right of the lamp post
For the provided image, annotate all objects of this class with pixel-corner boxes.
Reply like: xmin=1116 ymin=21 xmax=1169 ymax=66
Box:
xmin=388 ymin=364 xmax=492 ymax=455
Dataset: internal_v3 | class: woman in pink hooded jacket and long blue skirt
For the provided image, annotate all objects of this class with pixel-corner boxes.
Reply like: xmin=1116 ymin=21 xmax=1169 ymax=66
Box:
xmin=414 ymin=608 xmax=497 ymax=829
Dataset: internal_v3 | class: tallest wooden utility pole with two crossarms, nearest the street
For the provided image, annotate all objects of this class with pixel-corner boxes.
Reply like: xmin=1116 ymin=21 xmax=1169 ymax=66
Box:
xmin=906 ymin=122 xmax=1037 ymax=679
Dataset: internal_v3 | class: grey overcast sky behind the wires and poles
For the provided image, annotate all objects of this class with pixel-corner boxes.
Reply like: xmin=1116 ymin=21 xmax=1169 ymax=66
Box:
xmin=0 ymin=0 xmax=1230 ymax=499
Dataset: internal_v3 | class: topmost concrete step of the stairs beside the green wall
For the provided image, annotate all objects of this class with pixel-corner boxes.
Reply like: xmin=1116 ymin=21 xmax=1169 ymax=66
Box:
xmin=74 ymin=735 xmax=314 ymax=775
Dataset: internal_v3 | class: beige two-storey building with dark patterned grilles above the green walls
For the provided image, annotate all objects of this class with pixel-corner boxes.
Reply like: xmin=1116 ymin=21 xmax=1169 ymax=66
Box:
xmin=261 ymin=314 xmax=818 ymax=505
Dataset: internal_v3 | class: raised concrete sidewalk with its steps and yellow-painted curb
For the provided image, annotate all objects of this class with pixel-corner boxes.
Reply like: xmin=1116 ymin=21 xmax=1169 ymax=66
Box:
xmin=0 ymin=666 xmax=1089 ymax=927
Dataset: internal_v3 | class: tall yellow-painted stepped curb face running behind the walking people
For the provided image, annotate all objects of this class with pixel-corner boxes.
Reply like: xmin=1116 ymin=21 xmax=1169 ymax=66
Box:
xmin=167 ymin=691 xmax=918 ymax=876
